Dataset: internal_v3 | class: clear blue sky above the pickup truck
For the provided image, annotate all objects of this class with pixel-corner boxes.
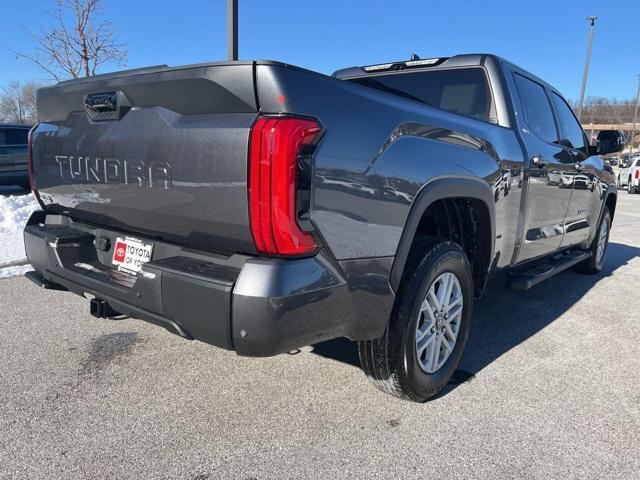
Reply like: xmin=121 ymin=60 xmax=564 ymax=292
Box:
xmin=0 ymin=0 xmax=640 ymax=99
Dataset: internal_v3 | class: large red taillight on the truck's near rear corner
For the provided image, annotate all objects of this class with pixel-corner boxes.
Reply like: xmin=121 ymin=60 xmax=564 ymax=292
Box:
xmin=249 ymin=117 xmax=321 ymax=255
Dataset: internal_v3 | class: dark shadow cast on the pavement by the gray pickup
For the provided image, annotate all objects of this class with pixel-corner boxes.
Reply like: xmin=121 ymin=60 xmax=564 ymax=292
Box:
xmin=312 ymin=243 xmax=640 ymax=398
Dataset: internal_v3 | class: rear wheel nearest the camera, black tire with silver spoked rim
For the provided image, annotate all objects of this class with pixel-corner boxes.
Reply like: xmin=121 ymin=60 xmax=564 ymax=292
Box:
xmin=358 ymin=237 xmax=473 ymax=402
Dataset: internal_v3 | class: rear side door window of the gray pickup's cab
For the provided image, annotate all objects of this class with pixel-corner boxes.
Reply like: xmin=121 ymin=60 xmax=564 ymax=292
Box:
xmin=513 ymin=73 xmax=558 ymax=143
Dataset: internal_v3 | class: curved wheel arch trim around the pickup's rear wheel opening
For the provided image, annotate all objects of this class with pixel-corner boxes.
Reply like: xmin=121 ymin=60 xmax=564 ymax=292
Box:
xmin=389 ymin=176 xmax=496 ymax=296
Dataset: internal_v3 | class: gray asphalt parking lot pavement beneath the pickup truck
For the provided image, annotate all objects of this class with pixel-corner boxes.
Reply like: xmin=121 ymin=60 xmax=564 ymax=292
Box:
xmin=0 ymin=191 xmax=640 ymax=480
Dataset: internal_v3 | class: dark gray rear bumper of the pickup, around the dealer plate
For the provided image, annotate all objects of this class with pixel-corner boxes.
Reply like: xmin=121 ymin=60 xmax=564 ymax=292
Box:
xmin=24 ymin=212 xmax=394 ymax=356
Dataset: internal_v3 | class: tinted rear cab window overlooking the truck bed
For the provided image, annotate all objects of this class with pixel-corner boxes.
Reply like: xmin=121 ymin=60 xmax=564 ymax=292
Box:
xmin=349 ymin=67 xmax=496 ymax=123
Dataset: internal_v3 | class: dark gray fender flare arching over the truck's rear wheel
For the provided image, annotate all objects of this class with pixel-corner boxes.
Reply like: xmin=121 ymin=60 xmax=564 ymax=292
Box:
xmin=389 ymin=176 xmax=496 ymax=292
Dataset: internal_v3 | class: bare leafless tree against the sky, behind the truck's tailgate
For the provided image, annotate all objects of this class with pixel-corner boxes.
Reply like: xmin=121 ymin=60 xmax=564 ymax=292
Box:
xmin=14 ymin=0 xmax=127 ymax=81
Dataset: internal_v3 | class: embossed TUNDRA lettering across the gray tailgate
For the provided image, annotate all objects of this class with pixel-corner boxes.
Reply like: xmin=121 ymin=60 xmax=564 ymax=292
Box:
xmin=55 ymin=155 xmax=173 ymax=190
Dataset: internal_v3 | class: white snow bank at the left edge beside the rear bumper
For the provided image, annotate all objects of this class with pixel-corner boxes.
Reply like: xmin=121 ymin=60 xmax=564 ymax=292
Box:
xmin=0 ymin=194 xmax=39 ymax=277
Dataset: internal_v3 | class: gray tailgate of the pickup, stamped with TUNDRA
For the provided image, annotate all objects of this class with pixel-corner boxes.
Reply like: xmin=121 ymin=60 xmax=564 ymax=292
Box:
xmin=32 ymin=62 xmax=258 ymax=253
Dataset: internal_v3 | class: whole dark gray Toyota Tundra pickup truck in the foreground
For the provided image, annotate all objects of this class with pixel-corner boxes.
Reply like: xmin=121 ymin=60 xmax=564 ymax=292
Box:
xmin=24 ymin=54 xmax=623 ymax=401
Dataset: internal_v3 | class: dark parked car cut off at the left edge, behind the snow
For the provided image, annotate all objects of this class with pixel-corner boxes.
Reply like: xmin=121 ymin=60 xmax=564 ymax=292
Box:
xmin=0 ymin=124 xmax=31 ymax=188
